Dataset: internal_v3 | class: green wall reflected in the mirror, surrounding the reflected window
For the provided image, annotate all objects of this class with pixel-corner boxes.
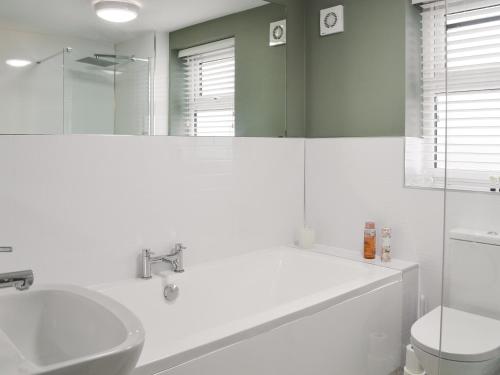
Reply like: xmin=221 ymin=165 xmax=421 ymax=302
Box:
xmin=170 ymin=4 xmax=287 ymax=137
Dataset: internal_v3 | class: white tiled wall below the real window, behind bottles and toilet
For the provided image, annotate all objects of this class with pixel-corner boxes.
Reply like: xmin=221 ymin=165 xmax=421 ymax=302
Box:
xmin=306 ymin=137 xmax=500 ymax=308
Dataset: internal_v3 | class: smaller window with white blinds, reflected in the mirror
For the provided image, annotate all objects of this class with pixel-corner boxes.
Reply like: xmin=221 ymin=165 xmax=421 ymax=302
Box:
xmin=179 ymin=39 xmax=235 ymax=136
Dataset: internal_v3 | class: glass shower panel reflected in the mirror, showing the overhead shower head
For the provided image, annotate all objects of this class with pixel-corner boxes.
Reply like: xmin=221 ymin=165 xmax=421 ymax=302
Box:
xmin=64 ymin=49 xmax=152 ymax=135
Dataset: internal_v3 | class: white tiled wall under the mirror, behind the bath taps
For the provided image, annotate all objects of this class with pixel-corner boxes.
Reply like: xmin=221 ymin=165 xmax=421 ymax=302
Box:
xmin=0 ymin=136 xmax=304 ymax=284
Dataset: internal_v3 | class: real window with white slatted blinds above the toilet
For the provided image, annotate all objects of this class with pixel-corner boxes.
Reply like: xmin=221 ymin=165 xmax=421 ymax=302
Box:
xmin=406 ymin=0 xmax=500 ymax=190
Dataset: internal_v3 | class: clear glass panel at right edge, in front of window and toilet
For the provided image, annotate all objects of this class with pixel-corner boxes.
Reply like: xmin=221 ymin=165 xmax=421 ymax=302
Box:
xmin=440 ymin=0 xmax=500 ymax=375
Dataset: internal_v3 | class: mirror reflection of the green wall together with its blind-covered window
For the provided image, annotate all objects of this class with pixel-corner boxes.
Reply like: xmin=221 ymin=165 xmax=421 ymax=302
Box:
xmin=170 ymin=2 xmax=286 ymax=136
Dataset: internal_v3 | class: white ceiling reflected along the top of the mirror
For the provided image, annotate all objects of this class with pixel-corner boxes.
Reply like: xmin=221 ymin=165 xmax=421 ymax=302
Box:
xmin=0 ymin=0 xmax=267 ymax=43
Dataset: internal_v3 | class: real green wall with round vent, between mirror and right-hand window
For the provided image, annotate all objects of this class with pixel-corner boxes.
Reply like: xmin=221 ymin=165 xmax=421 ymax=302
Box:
xmin=306 ymin=0 xmax=410 ymax=138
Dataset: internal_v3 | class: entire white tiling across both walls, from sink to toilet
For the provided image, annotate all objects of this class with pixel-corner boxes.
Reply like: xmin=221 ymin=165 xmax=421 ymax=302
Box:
xmin=0 ymin=136 xmax=494 ymax=308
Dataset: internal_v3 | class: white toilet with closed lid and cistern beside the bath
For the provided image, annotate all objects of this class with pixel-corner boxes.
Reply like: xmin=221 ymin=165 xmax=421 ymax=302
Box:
xmin=411 ymin=229 xmax=500 ymax=375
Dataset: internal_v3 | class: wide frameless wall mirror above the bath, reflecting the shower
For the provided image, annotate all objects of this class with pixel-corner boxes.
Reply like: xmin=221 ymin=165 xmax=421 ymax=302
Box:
xmin=0 ymin=0 xmax=287 ymax=137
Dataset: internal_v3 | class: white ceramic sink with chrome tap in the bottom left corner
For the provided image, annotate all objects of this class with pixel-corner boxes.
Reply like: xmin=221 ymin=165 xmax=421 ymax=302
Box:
xmin=0 ymin=285 xmax=144 ymax=375
